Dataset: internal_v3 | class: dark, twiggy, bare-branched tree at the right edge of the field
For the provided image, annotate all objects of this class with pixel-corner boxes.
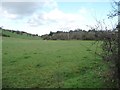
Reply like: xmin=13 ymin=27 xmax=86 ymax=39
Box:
xmin=90 ymin=1 xmax=120 ymax=88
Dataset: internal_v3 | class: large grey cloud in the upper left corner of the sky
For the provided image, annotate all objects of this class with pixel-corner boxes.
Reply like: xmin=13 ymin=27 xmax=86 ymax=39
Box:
xmin=2 ymin=2 xmax=43 ymax=17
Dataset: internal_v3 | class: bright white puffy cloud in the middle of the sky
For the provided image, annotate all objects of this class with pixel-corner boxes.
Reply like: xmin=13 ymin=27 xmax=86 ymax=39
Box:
xmin=29 ymin=8 xmax=85 ymax=26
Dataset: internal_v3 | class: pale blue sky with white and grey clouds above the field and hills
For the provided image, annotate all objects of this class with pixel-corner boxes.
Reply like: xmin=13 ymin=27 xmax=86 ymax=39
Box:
xmin=0 ymin=0 xmax=117 ymax=35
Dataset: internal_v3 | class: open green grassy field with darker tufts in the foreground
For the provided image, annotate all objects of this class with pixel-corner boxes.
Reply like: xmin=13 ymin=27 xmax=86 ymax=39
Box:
xmin=2 ymin=37 xmax=113 ymax=88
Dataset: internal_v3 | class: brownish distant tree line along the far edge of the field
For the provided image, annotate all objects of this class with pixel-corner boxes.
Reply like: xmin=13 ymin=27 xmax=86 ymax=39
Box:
xmin=41 ymin=29 xmax=117 ymax=40
